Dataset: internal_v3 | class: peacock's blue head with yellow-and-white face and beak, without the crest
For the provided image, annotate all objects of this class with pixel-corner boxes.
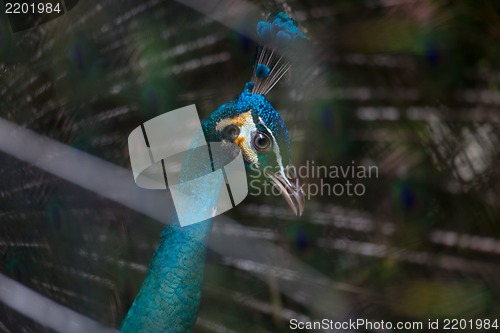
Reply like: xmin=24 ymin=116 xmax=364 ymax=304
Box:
xmin=203 ymin=82 xmax=304 ymax=215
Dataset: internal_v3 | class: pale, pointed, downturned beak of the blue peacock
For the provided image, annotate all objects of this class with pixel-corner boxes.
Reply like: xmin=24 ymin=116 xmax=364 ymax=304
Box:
xmin=265 ymin=166 xmax=305 ymax=216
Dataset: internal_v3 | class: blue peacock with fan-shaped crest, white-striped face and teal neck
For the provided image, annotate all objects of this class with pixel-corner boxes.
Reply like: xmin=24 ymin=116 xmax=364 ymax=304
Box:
xmin=121 ymin=12 xmax=306 ymax=333
